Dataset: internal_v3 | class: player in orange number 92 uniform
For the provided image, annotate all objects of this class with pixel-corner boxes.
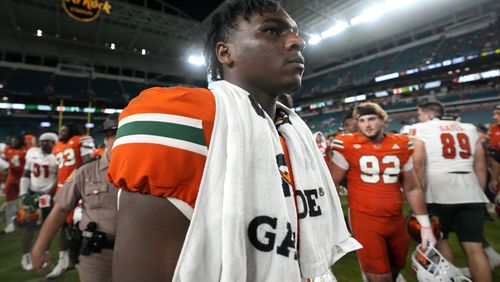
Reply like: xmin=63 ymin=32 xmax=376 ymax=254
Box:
xmin=332 ymin=103 xmax=436 ymax=281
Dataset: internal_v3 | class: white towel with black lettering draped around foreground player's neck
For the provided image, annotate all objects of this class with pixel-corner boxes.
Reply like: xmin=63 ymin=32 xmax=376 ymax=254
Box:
xmin=173 ymin=81 xmax=361 ymax=282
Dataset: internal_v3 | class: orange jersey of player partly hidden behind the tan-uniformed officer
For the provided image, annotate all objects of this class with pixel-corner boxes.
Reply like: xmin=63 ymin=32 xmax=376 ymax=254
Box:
xmin=52 ymin=135 xmax=94 ymax=188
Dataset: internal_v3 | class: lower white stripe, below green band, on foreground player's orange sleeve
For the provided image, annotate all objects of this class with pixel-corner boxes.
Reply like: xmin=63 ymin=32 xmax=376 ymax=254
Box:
xmin=113 ymin=134 xmax=208 ymax=156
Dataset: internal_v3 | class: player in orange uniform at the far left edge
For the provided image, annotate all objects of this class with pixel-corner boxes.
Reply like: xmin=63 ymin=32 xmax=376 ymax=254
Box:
xmin=3 ymin=135 xmax=29 ymax=233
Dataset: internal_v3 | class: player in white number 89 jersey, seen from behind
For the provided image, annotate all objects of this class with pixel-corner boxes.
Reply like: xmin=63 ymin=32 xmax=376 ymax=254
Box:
xmin=409 ymin=101 xmax=491 ymax=281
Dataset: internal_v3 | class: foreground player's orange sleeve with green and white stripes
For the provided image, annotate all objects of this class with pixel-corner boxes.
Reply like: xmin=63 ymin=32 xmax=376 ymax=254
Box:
xmin=108 ymin=87 xmax=215 ymax=207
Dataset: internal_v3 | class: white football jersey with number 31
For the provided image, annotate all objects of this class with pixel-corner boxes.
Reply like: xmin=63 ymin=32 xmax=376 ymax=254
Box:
xmin=24 ymin=147 xmax=58 ymax=192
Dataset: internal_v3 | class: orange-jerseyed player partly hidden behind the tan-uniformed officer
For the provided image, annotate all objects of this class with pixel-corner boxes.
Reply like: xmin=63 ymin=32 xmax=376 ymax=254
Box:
xmin=46 ymin=123 xmax=94 ymax=278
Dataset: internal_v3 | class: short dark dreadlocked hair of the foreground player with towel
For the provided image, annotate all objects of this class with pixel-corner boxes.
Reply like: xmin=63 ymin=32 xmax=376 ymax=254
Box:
xmin=204 ymin=0 xmax=283 ymax=81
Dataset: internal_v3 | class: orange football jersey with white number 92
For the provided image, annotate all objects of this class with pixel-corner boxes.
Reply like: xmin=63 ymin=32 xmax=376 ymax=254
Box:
xmin=332 ymin=133 xmax=413 ymax=217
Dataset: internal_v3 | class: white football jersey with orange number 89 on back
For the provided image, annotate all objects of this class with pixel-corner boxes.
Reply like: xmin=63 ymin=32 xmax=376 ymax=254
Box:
xmin=407 ymin=119 xmax=488 ymax=204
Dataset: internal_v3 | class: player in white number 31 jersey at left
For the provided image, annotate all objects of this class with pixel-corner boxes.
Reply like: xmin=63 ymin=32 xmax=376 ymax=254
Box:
xmin=19 ymin=132 xmax=58 ymax=270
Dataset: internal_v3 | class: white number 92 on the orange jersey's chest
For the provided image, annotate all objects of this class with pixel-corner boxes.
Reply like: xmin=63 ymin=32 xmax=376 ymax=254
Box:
xmin=359 ymin=155 xmax=400 ymax=184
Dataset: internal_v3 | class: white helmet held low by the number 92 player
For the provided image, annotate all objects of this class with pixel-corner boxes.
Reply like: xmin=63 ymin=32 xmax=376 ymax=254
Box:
xmin=411 ymin=245 xmax=471 ymax=282
